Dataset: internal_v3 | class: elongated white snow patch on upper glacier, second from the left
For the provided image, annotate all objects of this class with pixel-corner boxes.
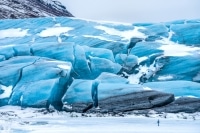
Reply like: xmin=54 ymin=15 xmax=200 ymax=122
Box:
xmin=38 ymin=27 xmax=73 ymax=37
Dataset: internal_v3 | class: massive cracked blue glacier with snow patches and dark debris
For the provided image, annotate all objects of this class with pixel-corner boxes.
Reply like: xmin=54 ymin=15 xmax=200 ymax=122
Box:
xmin=0 ymin=17 xmax=200 ymax=113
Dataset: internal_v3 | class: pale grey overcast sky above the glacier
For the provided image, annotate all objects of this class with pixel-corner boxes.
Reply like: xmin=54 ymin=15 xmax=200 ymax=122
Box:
xmin=59 ymin=0 xmax=200 ymax=23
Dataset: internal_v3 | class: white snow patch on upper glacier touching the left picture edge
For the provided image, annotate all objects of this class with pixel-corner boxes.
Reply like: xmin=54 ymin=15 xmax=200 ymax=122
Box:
xmin=0 ymin=28 xmax=28 ymax=39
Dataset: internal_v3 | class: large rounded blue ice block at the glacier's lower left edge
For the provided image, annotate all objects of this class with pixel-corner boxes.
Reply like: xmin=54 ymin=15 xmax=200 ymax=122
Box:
xmin=0 ymin=56 xmax=71 ymax=107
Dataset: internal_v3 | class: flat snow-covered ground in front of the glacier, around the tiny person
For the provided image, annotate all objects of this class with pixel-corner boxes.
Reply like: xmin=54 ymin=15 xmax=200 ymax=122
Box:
xmin=0 ymin=106 xmax=200 ymax=133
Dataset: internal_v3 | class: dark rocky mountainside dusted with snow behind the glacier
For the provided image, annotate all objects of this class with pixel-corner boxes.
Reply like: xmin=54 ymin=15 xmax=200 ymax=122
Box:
xmin=0 ymin=0 xmax=73 ymax=19
